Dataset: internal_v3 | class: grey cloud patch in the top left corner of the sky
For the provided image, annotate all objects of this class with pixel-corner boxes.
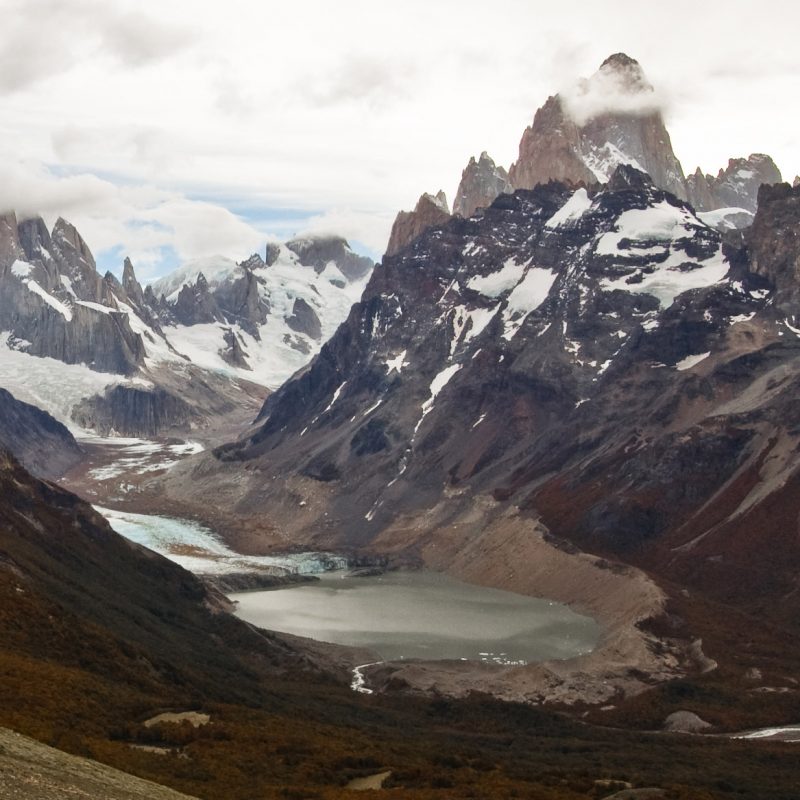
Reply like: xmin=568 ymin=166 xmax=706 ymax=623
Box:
xmin=0 ymin=0 xmax=197 ymax=94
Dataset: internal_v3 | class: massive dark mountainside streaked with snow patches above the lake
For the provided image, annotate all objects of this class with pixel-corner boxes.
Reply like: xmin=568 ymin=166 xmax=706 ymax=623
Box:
xmin=204 ymin=167 xmax=800 ymax=620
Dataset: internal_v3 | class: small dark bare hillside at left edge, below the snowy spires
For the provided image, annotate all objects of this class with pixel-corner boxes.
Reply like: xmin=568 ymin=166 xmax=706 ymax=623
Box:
xmin=0 ymin=389 xmax=83 ymax=480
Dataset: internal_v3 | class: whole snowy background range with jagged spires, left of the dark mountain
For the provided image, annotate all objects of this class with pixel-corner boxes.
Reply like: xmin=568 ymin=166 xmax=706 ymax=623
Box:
xmin=0 ymin=214 xmax=372 ymax=435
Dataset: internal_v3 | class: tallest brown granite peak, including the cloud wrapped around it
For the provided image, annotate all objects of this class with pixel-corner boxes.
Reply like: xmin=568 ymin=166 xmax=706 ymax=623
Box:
xmin=509 ymin=53 xmax=686 ymax=197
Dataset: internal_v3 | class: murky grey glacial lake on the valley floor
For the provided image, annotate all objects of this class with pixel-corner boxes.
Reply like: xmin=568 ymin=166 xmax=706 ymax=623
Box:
xmin=231 ymin=572 xmax=600 ymax=664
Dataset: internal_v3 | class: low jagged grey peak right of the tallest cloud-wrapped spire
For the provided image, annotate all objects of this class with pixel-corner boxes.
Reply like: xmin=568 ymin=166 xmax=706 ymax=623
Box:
xmin=687 ymin=153 xmax=782 ymax=214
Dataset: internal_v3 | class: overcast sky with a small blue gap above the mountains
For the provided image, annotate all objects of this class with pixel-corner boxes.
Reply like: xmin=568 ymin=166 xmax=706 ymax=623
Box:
xmin=0 ymin=0 xmax=800 ymax=278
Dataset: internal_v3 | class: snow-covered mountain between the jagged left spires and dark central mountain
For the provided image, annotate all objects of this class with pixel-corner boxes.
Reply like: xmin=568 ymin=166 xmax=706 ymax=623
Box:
xmin=148 ymin=237 xmax=372 ymax=389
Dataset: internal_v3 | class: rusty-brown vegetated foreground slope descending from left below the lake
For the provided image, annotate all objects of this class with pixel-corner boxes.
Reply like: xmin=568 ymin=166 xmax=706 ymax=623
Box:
xmin=0 ymin=450 xmax=800 ymax=800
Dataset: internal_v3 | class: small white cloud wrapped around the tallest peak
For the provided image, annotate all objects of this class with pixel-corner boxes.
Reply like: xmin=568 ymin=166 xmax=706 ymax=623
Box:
xmin=559 ymin=55 xmax=666 ymax=126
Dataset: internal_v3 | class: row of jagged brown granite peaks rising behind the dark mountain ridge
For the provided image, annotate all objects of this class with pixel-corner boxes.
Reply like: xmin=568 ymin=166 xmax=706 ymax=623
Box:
xmin=387 ymin=53 xmax=781 ymax=255
